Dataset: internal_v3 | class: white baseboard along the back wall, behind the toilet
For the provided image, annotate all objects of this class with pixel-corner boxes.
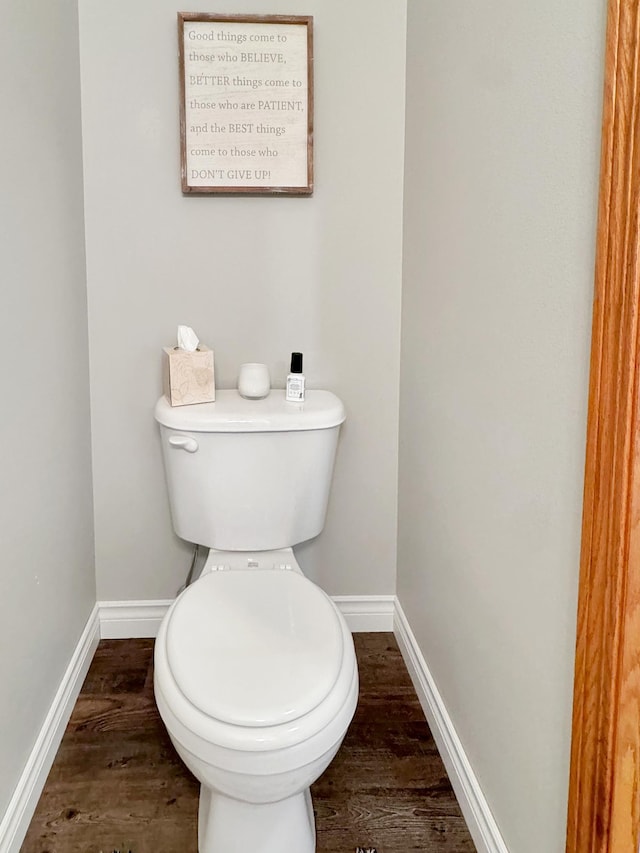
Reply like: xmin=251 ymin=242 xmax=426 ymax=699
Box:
xmin=98 ymin=595 xmax=396 ymax=640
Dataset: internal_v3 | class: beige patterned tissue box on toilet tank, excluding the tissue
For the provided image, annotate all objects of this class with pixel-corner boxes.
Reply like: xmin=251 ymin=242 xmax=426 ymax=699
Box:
xmin=164 ymin=344 xmax=216 ymax=406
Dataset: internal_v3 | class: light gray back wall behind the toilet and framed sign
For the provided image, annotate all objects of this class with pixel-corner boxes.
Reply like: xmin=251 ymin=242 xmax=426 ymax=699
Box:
xmin=80 ymin=0 xmax=405 ymax=599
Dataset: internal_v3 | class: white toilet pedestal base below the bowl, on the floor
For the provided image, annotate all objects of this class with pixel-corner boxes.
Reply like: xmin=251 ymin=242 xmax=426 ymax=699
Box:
xmin=198 ymin=785 xmax=316 ymax=853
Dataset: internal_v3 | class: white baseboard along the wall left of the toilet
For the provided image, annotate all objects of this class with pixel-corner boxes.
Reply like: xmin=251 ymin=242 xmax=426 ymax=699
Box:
xmin=0 ymin=605 xmax=100 ymax=853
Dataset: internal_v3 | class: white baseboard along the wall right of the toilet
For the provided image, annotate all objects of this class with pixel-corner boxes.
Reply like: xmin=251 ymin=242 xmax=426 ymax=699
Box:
xmin=394 ymin=600 xmax=509 ymax=853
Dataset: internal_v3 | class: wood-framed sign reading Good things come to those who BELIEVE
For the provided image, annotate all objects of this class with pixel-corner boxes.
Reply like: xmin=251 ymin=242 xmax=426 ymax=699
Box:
xmin=178 ymin=12 xmax=313 ymax=195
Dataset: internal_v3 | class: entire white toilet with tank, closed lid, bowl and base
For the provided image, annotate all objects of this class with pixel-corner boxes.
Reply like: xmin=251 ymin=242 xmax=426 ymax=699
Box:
xmin=154 ymin=390 xmax=358 ymax=853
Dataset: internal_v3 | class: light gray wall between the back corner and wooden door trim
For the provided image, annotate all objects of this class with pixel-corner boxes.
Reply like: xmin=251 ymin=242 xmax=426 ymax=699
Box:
xmin=398 ymin=0 xmax=606 ymax=853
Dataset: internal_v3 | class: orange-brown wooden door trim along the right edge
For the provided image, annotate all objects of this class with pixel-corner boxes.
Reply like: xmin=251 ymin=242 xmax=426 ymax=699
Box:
xmin=566 ymin=0 xmax=640 ymax=853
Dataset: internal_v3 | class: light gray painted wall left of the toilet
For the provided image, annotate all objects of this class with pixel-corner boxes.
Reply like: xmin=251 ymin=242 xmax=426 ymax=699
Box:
xmin=0 ymin=0 xmax=95 ymax=815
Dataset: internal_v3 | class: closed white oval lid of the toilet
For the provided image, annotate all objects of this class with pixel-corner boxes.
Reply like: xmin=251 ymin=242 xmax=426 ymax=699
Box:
xmin=166 ymin=570 xmax=343 ymax=726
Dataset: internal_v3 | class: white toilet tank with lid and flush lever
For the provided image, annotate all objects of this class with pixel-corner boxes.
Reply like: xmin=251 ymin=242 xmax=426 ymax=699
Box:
xmin=155 ymin=390 xmax=345 ymax=551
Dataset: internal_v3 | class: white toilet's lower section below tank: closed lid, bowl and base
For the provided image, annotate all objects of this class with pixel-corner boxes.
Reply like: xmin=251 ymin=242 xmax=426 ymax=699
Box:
xmin=154 ymin=551 xmax=358 ymax=853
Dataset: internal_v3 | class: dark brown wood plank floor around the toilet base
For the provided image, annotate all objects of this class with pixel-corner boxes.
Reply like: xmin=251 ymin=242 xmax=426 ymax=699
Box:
xmin=21 ymin=634 xmax=475 ymax=853
